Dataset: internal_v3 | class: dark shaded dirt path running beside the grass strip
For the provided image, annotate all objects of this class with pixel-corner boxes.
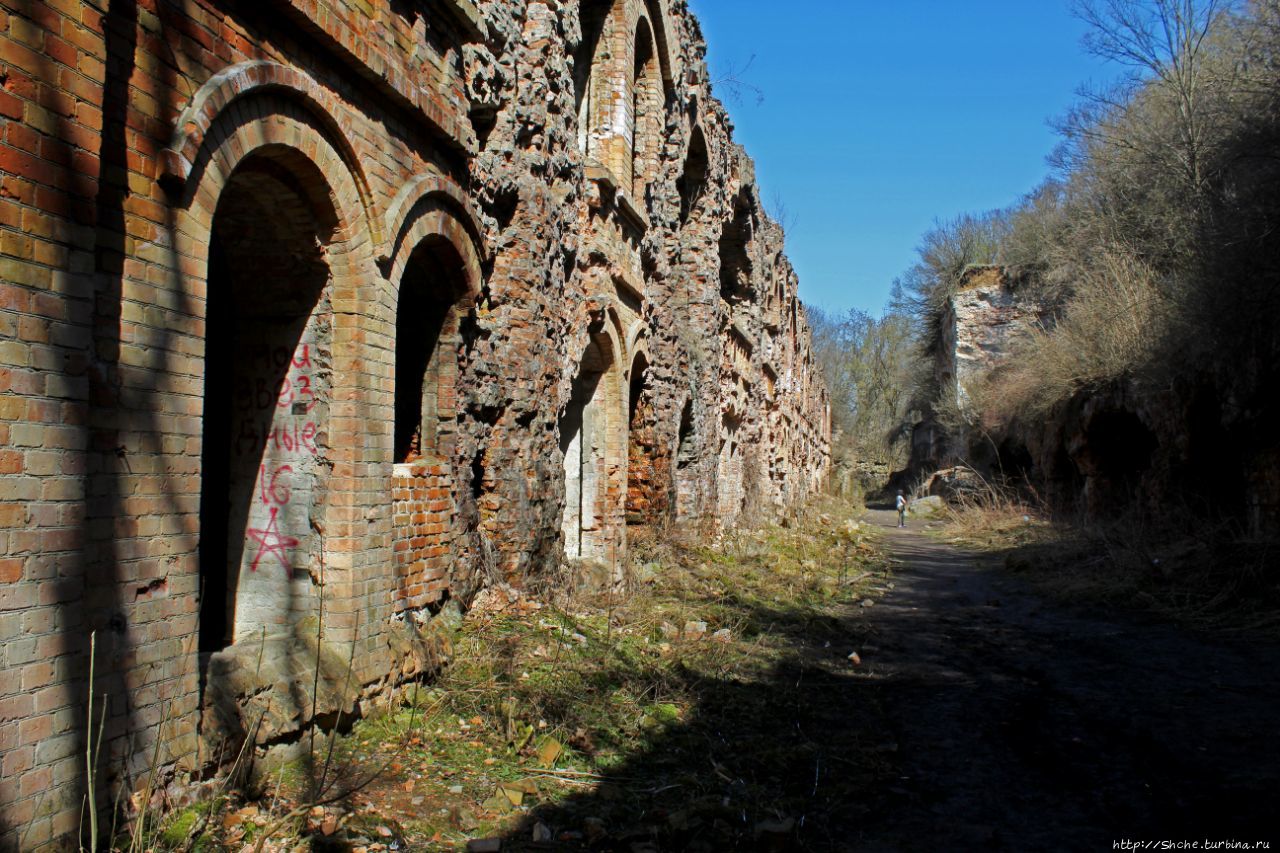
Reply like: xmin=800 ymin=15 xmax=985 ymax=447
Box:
xmin=851 ymin=511 xmax=1280 ymax=849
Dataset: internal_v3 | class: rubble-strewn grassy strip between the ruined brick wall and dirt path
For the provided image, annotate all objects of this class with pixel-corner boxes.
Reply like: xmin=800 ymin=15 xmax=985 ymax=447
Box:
xmin=137 ymin=502 xmax=888 ymax=850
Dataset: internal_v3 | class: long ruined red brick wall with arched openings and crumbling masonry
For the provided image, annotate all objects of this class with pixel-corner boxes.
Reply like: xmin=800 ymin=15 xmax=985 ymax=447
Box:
xmin=0 ymin=0 xmax=829 ymax=849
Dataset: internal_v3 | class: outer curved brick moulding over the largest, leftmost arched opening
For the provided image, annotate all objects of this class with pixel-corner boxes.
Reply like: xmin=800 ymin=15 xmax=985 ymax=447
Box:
xmin=159 ymin=60 xmax=383 ymax=243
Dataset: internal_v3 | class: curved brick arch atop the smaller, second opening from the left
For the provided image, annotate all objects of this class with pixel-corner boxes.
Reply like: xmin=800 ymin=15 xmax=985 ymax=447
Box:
xmin=380 ymin=174 xmax=486 ymax=296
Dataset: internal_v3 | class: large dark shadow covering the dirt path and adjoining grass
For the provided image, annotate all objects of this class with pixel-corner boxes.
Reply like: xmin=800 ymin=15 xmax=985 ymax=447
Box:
xmin=503 ymin=512 xmax=1280 ymax=850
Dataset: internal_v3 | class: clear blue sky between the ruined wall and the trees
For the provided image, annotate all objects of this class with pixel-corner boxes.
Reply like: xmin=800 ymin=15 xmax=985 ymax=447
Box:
xmin=690 ymin=0 xmax=1117 ymax=314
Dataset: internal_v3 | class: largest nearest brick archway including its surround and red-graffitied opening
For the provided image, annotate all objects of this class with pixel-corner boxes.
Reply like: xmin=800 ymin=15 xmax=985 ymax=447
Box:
xmin=174 ymin=91 xmax=376 ymax=653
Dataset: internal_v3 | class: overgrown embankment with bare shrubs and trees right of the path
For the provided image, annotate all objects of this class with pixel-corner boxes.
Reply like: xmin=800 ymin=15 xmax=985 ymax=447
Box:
xmin=815 ymin=0 xmax=1280 ymax=537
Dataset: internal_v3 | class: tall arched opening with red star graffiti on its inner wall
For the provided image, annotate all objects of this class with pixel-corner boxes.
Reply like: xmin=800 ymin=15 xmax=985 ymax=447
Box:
xmin=200 ymin=145 xmax=337 ymax=652
